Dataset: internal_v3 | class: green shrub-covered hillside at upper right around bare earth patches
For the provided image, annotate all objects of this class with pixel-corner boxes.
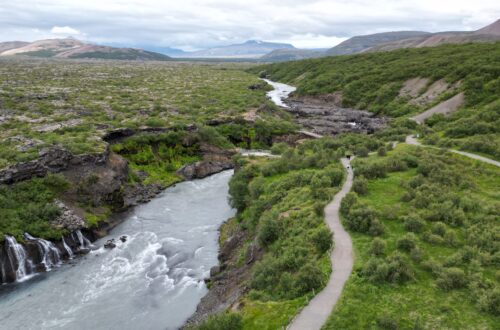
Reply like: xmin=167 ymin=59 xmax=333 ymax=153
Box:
xmin=254 ymin=42 xmax=500 ymax=159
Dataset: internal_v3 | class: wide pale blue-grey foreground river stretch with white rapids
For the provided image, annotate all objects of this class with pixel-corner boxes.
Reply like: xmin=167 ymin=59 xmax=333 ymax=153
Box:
xmin=0 ymin=171 xmax=235 ymax=330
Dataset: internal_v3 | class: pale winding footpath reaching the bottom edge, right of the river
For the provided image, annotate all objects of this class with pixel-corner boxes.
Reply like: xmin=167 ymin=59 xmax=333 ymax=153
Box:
xmin=287 ymin=158 xmax=354 ymax=330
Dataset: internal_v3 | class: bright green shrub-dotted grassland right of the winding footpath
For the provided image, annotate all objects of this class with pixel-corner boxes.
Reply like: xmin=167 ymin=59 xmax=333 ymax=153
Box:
xmin=324 ymin=144 xmax=500 ymax=329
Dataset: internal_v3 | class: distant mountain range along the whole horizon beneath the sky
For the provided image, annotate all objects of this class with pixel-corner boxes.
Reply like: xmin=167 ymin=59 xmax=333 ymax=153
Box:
xmin=0 ymin=20 xmax=500 ymax=62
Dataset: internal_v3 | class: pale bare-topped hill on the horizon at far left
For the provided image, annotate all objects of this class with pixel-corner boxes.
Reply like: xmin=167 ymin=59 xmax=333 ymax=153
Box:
xmin=0 ymin=38 xmax=170 ymax=61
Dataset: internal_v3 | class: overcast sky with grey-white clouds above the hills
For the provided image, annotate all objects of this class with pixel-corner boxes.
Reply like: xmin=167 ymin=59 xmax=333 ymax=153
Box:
xmin=0 ymin=0 xmax=500 ymax=50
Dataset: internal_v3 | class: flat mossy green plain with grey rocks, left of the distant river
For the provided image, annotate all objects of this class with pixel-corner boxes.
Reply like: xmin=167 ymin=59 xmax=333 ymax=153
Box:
xmin=0 ymin=59 xmax=274 ymax=168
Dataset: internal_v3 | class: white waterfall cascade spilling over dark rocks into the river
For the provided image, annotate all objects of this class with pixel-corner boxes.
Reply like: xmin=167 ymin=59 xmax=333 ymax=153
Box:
xmin=0 ymin=230 xmax=92 ymax=284
